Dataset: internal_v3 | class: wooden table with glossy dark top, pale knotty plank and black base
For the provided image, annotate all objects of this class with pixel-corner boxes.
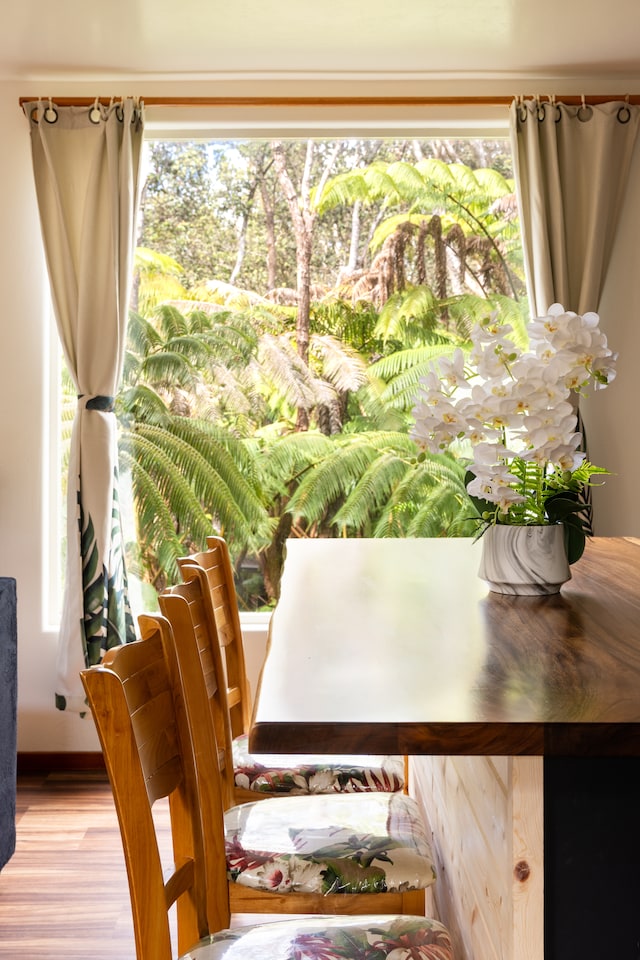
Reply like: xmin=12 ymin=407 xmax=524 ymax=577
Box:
xmin=249 ymin=537 xmax=640 ymax=960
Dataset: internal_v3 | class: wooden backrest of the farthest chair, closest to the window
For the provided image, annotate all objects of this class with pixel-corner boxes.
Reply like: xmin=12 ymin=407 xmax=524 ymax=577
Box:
xmin=178 ymin=536 xmax=251 ymax=737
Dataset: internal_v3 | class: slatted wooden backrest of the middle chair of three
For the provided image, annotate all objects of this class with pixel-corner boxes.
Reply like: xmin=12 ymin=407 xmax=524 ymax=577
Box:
xmin=158 ymin=577 xmax=235 ymax=809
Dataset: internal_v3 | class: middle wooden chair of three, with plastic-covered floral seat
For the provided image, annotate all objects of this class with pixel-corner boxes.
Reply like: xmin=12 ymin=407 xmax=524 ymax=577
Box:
xmin=159 ymin=578 xmax=435 ymax=914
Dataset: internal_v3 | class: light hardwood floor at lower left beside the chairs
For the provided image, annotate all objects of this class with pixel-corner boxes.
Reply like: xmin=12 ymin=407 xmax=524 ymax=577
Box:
xmin=0 ymin=772 xmax=169 ymax=960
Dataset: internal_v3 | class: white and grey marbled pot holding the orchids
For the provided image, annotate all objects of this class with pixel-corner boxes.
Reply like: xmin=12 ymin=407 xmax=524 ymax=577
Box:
xmin=478 ymin=523 xmax=571 ymax=597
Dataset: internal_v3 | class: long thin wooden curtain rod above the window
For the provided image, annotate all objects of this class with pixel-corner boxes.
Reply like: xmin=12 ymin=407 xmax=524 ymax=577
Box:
xmin=18 ymin=94 xmax=640 ymax=107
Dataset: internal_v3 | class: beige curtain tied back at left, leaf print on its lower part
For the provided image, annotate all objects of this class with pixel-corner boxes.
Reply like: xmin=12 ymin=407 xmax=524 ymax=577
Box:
xmin=24 ymin=99 xmax=143 ymax=712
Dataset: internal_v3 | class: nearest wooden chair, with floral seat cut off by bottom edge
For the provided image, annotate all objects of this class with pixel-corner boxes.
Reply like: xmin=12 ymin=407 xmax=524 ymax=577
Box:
xmin=81 ymin=616 xmax=453 ymax=960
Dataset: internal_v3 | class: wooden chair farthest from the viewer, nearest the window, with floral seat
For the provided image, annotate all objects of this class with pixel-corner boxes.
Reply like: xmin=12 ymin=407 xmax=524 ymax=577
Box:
xmin=178 ymin=536 xmax=407 ymax=802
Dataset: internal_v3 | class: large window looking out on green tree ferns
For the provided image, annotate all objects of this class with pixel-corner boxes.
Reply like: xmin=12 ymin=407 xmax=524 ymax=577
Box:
xmin=51 ymin=114 xmax=526 ymax=624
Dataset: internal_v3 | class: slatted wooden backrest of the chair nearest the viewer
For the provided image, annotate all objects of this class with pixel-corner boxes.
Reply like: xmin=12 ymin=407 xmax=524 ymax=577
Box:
xmin=81 ymin=616 xmax=229 ymax=960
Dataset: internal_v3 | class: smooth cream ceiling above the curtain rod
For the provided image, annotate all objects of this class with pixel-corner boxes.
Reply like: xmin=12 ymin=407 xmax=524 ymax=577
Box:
xmin=0 ymin=0 xmax=640 ymax=86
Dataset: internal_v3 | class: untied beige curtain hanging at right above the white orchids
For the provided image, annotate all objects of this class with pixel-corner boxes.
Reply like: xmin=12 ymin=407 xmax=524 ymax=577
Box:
xmin=510 ymin=100 xmax=640 ymax=316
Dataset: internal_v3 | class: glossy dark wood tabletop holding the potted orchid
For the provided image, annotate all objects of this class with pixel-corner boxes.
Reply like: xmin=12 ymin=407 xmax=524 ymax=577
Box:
xmin=250 ymin=538 xmax=640 ymax=756
